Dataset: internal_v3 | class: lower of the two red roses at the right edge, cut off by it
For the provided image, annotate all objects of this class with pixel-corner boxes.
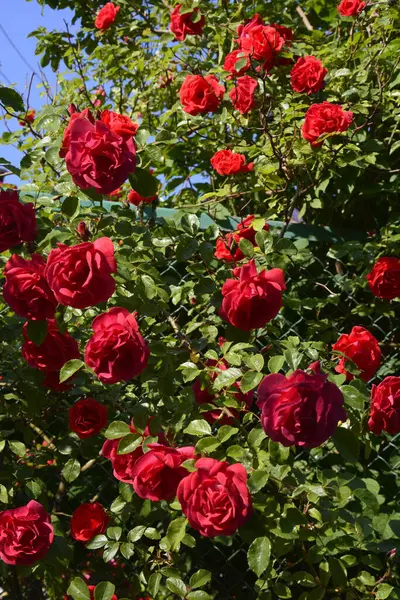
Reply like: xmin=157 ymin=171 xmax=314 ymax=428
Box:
xmin=368 ymin=377 xmax=400 ymax=435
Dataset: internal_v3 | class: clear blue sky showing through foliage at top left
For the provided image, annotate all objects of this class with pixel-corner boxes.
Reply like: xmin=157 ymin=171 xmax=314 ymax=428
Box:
xmin=0 ymin=0 xmax=73 ymax=183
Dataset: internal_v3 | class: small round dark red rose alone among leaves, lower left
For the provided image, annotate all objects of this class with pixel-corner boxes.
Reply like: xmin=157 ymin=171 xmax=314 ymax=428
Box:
xmin=68 ymin=398 xmax=107 ymax=440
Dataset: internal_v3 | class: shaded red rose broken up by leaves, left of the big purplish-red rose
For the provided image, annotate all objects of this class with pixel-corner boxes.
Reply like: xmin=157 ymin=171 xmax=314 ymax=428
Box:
xmin=192 ymin=360 xmax=254 ymax=425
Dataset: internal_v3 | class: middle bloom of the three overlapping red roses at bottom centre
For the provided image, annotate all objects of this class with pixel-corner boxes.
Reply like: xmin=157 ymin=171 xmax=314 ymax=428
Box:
xmin=132 ymin=444 xmax=195 ymax=502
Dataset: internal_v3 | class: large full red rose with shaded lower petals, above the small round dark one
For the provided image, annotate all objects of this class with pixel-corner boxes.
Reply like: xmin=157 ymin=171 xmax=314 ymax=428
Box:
xmin=85 ymin=306 xmax=150 ymax=383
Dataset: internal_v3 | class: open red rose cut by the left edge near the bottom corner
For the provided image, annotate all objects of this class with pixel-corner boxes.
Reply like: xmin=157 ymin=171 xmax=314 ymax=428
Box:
xmin=0 ymin=500 xmax=54 ymax=565
